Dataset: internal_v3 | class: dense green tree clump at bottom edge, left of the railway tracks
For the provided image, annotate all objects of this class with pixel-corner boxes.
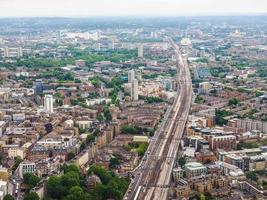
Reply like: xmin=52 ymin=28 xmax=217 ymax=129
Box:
xmin=46 ymin=165 xmax=129 ymax=200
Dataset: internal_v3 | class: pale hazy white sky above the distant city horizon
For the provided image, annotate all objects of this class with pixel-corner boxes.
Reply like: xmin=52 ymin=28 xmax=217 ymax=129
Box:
xmin=0 ymin=0 xmax=267 ymax=17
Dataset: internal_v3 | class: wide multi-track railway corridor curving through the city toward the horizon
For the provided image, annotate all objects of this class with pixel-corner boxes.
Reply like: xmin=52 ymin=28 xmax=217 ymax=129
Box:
xmin=124 ymin=39 xmax=192 ymax=200
